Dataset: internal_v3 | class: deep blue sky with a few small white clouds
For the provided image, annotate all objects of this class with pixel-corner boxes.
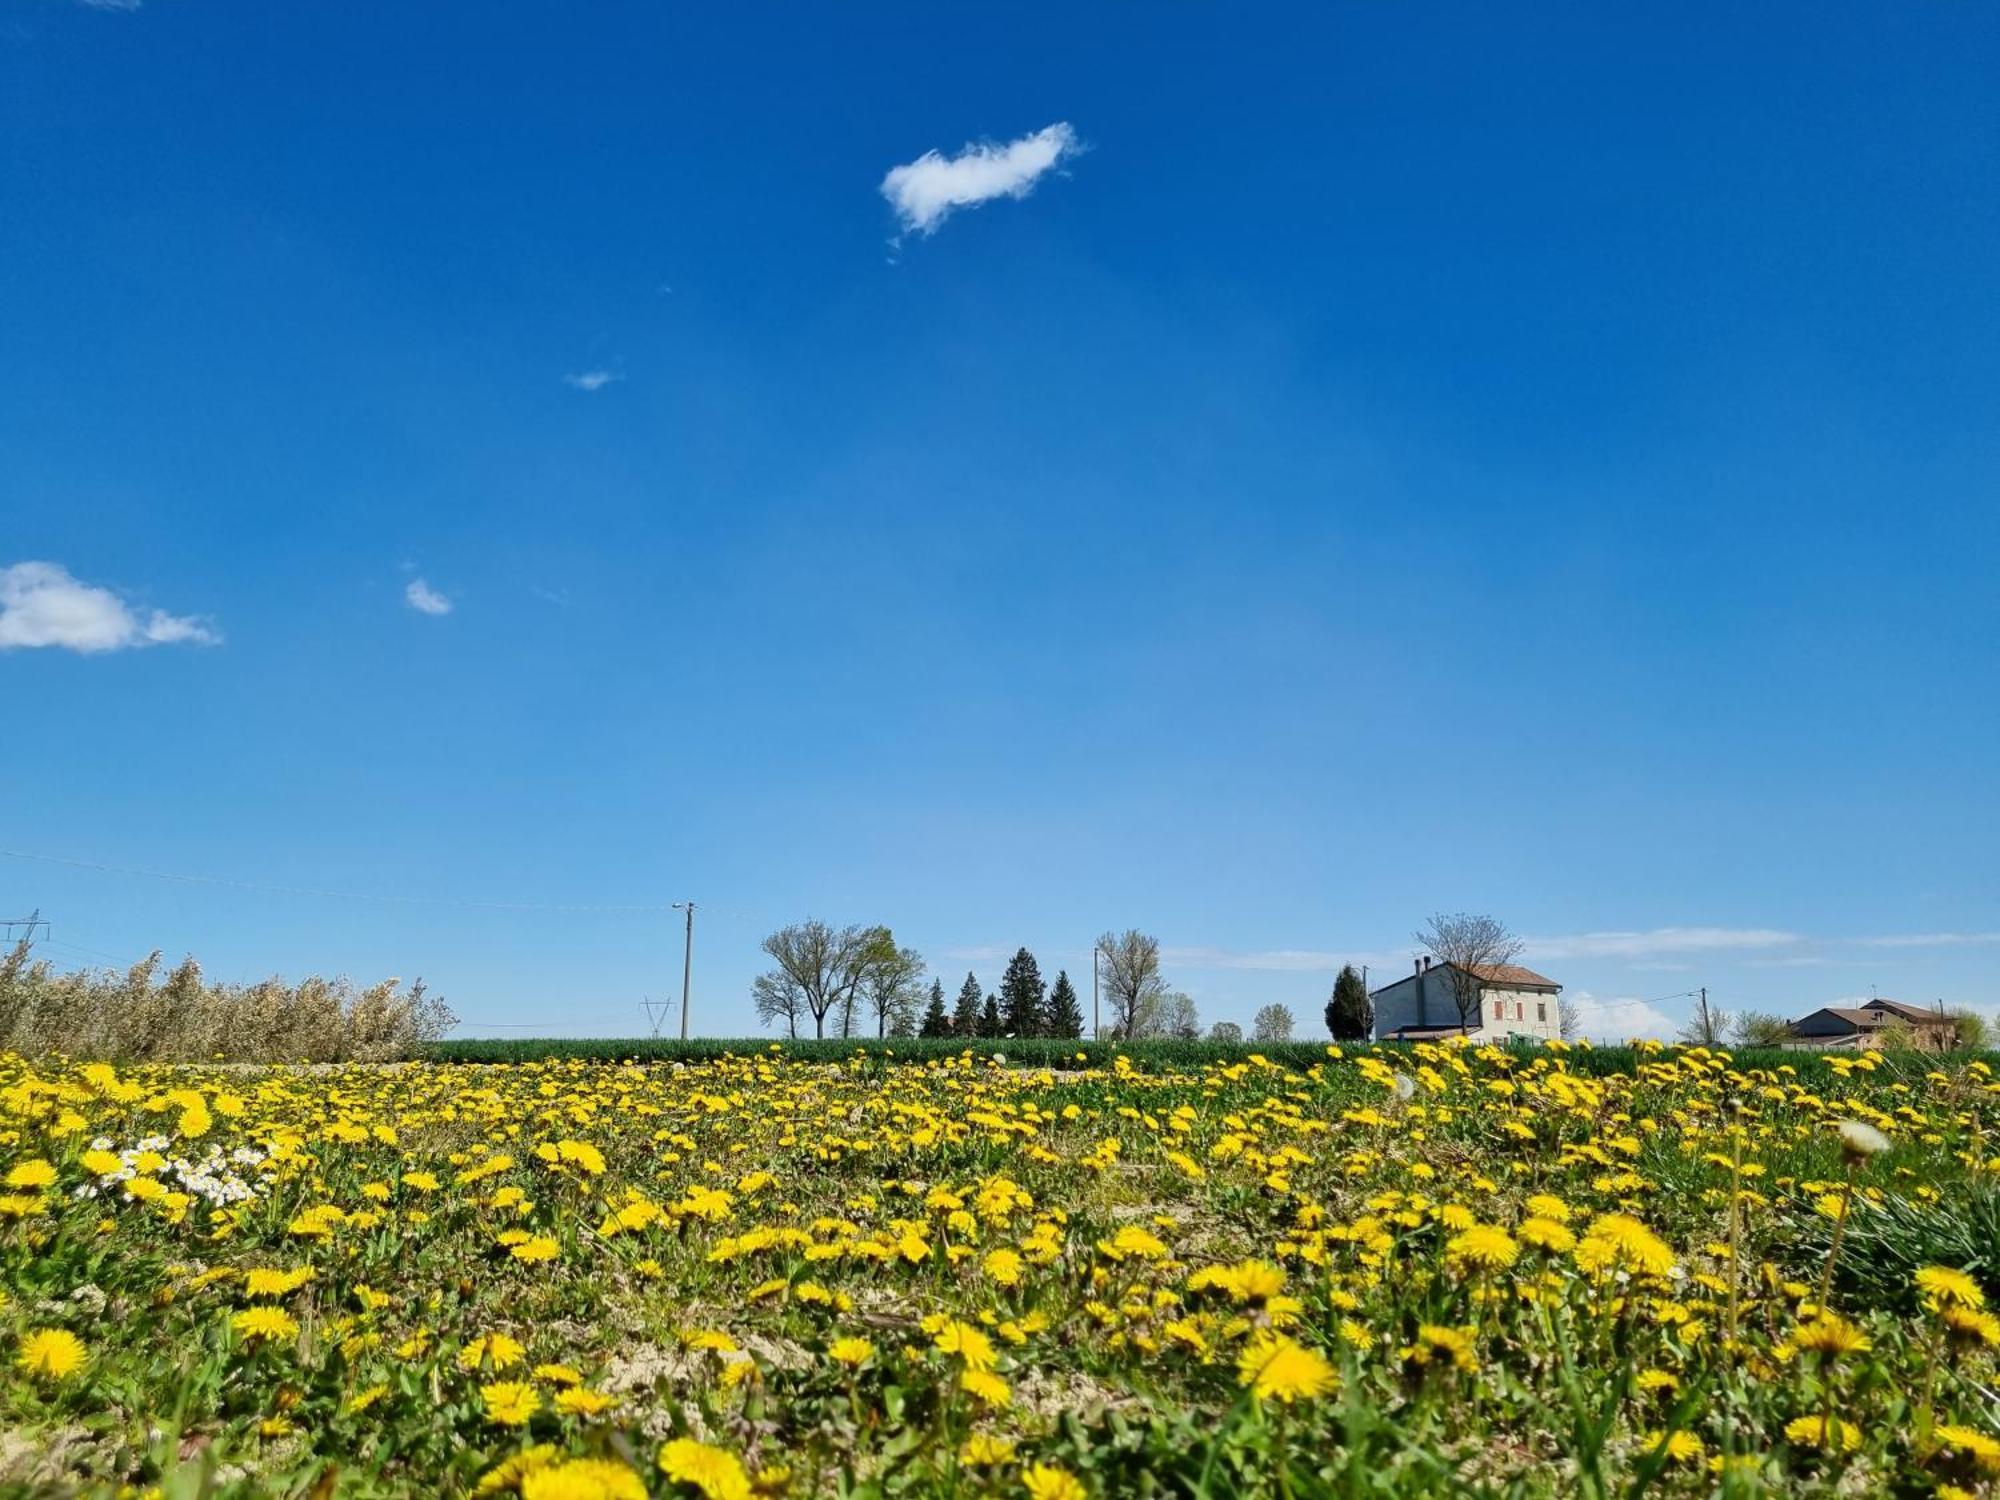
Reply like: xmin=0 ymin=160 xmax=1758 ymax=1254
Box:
xmin=0 ymin=0 xmax=2000 ymax=1034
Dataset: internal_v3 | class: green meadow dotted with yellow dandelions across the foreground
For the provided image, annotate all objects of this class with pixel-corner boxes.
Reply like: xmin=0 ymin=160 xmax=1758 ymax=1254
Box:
xmin=0 ymin=1046 xmax=2000 ymax=1500
